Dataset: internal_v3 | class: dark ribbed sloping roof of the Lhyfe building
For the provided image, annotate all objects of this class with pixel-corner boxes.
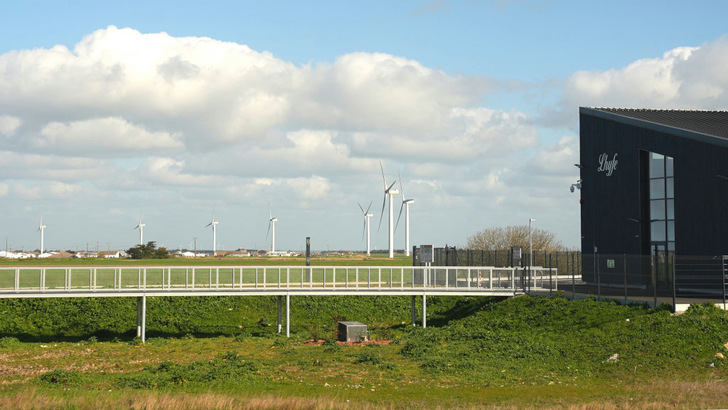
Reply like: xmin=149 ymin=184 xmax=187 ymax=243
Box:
xmin=580 ymin=107 xmax=728 ymax=140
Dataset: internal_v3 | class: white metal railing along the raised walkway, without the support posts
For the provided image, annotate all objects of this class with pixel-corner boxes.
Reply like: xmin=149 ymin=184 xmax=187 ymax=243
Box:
xmin=0 ymin=266 xmax=555 ymax=296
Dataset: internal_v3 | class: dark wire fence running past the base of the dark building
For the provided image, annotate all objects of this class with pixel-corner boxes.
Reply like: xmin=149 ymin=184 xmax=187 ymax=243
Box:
xmin=413 ymin=247 xmax=728 ymax=307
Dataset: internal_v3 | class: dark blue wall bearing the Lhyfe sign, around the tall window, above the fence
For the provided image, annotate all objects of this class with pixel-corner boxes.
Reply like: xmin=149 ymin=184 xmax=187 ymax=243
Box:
xmin=580 ymin=108 xmax=728 ymax=284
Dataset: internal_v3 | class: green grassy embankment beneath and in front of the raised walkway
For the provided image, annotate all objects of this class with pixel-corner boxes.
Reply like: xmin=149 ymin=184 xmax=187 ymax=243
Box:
xmin=0 ymin=258 xmax=728 ymax=408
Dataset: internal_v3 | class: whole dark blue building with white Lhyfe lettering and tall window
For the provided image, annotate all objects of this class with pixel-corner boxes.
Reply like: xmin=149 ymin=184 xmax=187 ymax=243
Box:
xmin=578 ymin=107 xmax=728 ymax=292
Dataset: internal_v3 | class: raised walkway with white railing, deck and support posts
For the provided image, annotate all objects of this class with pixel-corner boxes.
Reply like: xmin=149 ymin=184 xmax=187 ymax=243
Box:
xmin=0 ymin=266 xmax=555 ymax=340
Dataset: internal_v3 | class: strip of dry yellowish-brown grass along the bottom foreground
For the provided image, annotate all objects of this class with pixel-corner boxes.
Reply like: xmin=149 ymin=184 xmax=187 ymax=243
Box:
xmin=0 ymin=380 xmax=728 ymax=410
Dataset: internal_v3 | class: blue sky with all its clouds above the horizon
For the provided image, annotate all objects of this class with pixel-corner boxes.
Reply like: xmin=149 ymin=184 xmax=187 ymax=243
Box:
xmin=0 ymin=0 xmax=728 ymax=251
